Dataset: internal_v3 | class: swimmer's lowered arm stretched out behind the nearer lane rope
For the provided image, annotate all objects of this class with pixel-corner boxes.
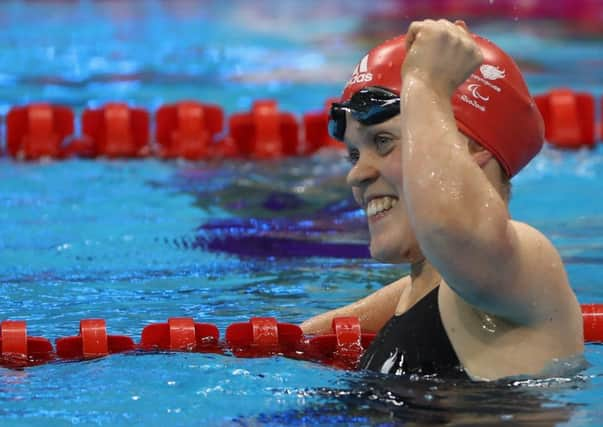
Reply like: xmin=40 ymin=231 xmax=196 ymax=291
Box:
xmin=301 ymin=277 xmax=409 ymax=334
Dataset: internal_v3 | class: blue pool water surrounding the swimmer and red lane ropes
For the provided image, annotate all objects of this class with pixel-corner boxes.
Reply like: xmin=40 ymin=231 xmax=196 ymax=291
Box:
xmin=0 ymin=0 xmax=603 ymax=426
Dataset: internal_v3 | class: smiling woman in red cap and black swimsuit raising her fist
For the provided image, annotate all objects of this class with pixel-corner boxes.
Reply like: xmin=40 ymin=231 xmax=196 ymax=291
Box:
xmin=302 ymin=20 xmax=583 ymax=380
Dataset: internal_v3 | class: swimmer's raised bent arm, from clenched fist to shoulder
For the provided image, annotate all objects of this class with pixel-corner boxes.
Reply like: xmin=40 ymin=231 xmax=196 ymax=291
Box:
xmin=401 ymin=21 xmax=575 ymax=324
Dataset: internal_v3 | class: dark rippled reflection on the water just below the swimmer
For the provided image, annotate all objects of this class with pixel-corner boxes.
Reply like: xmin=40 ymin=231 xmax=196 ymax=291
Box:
xmin=239 ymin=373 xmax=587 ymax=426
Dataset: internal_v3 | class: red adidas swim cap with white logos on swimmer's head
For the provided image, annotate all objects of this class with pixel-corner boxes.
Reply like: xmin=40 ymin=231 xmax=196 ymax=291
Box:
xmin=341 ymin=34 xmax=544 ymax=177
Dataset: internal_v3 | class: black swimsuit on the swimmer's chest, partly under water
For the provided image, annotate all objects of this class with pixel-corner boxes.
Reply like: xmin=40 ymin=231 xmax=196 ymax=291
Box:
xmin=360 ymin=286 xmax=462 ymax=376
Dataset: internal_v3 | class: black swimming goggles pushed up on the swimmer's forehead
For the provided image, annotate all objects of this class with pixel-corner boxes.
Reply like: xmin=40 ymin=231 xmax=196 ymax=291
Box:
xmin=329 ymin=86 xmax=400 ymax=141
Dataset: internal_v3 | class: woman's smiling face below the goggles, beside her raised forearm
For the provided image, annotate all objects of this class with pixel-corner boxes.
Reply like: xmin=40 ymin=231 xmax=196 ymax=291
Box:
xmin=344 ymin=113 xmax=423 ymax=263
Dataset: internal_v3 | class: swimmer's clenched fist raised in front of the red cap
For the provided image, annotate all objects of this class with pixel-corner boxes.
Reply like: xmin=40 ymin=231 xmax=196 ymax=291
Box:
xmin=401 ymin=19 xmax=483 ymax=96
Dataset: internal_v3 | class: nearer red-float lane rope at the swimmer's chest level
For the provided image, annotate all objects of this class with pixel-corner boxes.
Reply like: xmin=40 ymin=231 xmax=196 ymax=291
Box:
xmin=0 ymin=304 xmax=603 ymax=370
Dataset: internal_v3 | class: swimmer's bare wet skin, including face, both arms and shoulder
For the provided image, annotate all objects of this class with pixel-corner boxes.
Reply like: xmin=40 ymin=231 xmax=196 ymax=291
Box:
xmin=302 ymin=20 xmax=583 ymax=380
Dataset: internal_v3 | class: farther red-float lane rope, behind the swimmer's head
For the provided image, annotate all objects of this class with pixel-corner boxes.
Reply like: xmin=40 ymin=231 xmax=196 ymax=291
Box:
xmin=6 ymin=88 xmax=603 ymax=160
